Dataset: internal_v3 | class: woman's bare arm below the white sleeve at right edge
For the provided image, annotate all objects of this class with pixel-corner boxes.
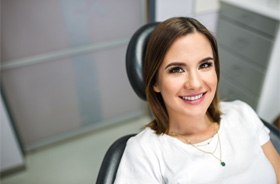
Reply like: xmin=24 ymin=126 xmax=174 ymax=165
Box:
xmin=262 ymin=141 xmax=280 ymax=184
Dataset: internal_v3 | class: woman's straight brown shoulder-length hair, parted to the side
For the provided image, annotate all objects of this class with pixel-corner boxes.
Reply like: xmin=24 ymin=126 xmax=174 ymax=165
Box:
xmin=143 ymin=17 xmax=221 ymax=134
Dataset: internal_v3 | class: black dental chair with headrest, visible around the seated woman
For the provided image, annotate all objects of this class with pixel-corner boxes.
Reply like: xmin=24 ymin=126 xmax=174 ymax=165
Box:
xmin=96 ymin=23 xmax=280 ymax=184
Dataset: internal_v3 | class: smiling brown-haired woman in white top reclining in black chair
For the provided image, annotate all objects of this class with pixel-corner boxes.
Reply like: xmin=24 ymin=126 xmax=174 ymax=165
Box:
xmin=115 ymin=17 xmax=280 ymax=184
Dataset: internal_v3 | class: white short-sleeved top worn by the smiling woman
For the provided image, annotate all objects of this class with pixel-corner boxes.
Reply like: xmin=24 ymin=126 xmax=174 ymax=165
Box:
xmin=115 ymin=101 xmax=276 ymax=184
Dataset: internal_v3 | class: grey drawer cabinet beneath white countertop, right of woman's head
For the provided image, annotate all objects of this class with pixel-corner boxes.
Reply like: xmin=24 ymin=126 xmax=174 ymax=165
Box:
xmin=217 ymin=2 xmax=279 ymax=112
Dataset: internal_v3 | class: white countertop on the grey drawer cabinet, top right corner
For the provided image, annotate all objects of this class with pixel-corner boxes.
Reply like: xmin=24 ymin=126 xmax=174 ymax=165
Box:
xmin=221 ymin=0 xmax=280 ymax=21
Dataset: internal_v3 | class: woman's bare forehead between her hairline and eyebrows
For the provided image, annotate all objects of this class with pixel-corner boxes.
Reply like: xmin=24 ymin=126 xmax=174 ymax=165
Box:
xmin=162 ymin=32 xmax=213 ymax=64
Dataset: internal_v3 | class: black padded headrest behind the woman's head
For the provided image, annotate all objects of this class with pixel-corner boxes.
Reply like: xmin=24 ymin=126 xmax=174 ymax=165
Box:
xmin=126 ymin=22 xmax=158 ymax=100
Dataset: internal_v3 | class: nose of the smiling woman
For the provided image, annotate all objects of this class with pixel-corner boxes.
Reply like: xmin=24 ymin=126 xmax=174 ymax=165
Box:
xmin=185 ymin=71 xmax=202 ymax=90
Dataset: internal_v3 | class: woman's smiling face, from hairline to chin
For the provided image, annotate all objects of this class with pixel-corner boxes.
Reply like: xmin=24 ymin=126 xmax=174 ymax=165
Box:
xmin=153 ymin=32 xmax=217 ymax=119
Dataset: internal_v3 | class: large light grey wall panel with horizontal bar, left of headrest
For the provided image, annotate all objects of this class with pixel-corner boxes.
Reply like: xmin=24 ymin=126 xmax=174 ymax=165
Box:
xmin=1 ymin=0 xmax=146 ymax=149
